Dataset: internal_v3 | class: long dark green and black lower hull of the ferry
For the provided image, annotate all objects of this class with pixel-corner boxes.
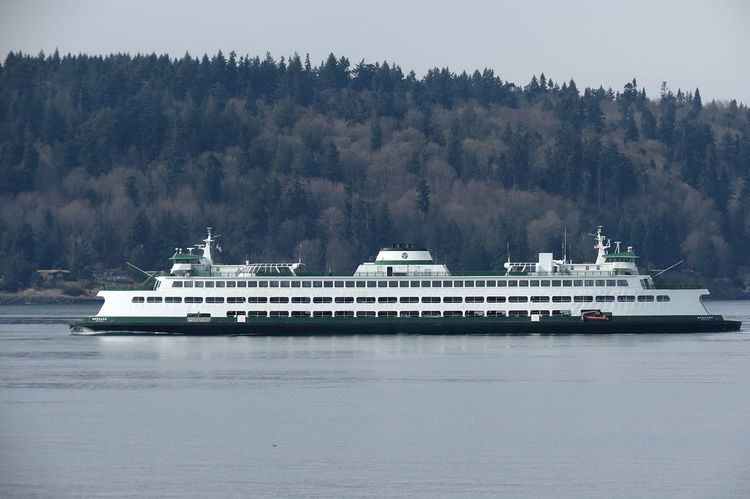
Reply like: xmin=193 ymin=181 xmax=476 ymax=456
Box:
xmin=70 ymin=316 xmax=742 ymax=336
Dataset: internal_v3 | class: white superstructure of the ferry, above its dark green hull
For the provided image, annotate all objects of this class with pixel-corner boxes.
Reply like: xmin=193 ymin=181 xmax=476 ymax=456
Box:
xmin=92 ymin=227 xmax=709 ymax=322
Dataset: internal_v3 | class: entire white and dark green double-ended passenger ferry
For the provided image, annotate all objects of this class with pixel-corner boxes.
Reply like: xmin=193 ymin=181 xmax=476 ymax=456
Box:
xmin=71 ymin=227 xmax=741 ymax=335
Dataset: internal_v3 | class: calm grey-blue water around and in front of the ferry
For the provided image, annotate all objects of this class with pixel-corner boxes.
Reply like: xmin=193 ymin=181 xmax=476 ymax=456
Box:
xmin=0 ymin=302 xmax=750 ymax=498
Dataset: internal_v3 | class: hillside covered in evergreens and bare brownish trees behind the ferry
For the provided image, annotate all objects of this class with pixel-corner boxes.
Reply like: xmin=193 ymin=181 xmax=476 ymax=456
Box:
xmin=0 ymin=53 xmax=750 ymax=290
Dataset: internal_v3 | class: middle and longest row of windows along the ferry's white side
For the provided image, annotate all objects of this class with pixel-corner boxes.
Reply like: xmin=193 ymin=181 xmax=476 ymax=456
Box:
xmin=131 ymin=295 xmax=671 ymax=304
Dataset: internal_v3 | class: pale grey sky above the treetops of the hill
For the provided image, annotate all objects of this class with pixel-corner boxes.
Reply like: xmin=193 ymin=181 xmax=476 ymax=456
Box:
xmin=0 ymin=0 xmax=750 ymax=104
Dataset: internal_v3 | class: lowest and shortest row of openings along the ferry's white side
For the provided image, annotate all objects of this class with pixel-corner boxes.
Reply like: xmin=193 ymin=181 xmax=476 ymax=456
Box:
xmin=227 ymin=310 xmax=570 ymax=317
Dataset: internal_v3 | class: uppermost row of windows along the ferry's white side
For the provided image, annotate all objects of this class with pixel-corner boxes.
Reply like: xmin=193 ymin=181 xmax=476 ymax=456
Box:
xmin=172 ymin=279 xmax=628 ymax=288
